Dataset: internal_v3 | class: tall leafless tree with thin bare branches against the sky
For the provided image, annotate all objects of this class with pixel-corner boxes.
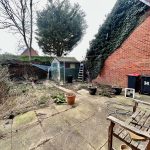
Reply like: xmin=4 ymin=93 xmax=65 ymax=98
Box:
xmin=0 ymin=0 xmax=33 ymax=60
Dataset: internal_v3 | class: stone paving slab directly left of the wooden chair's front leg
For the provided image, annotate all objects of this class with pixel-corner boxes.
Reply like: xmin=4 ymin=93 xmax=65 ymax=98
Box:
xmin=74 ymin=105 xmax=108 ymax=149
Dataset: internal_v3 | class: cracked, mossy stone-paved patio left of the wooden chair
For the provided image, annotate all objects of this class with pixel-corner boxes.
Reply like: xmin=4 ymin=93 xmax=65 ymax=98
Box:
xmin=0 ymin=84 xmax=144 ymax=150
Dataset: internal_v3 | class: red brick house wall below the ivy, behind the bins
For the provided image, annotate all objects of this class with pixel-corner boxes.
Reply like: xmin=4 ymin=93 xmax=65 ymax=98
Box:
xmin=95 ymin=16 xmax=150 ymax=87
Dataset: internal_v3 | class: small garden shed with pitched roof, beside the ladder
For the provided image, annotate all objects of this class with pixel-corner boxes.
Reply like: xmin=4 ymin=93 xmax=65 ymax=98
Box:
xmin=51 ymin=57 xmax=80 ymax=82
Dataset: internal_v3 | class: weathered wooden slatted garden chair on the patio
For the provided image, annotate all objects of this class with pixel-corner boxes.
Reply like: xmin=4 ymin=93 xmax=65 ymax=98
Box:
xmin=107 ymin=99 xmax=150 ymax=150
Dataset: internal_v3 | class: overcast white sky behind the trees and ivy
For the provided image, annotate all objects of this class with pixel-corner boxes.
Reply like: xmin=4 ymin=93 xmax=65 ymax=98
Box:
xmin=0 ymin=0 xmax=117 ymax=60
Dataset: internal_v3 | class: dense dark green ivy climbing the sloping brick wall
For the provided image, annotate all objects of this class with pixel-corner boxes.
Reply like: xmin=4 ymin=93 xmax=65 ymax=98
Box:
xmin=86 ymin=0 xmax=149 ymax=79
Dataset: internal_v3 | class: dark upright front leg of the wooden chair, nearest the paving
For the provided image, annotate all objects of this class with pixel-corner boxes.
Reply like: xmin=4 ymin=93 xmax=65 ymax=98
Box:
xmin=108 ymin=122 xmax=115 ymax=150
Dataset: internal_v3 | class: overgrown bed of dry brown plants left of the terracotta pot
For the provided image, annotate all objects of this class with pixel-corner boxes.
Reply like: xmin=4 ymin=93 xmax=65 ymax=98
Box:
xmin=0 ymin=82 xmax=64 ymax=119
